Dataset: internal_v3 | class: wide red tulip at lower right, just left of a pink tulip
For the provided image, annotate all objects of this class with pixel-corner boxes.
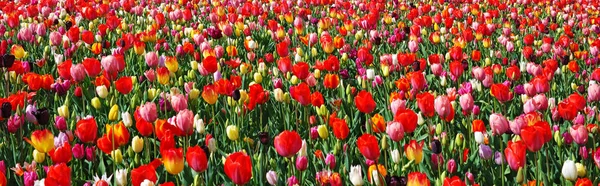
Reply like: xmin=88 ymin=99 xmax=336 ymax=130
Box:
xmin=521 ymin=121 xmax=552 ymax=152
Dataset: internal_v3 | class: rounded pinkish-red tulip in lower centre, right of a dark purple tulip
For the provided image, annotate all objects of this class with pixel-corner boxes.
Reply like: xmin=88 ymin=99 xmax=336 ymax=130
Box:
xmin=273 ymin=130 xmax=302 ymax=157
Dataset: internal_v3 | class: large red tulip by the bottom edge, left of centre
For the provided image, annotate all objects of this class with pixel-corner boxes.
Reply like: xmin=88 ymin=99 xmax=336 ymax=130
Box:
xmin=224 ymin=152 xmax=252 ymax=185
